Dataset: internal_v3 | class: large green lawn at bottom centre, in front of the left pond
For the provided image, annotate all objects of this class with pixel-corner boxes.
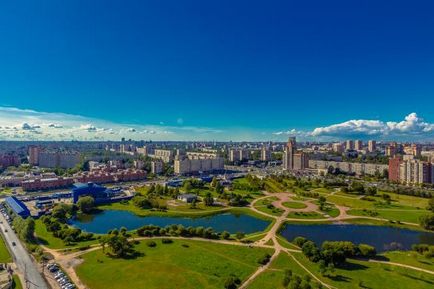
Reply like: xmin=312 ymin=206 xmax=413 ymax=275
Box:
xmin=76 ymin=239 xmax=272 ymax=289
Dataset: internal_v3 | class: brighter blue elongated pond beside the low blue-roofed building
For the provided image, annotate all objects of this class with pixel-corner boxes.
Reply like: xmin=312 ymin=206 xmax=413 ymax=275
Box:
xmin=70 ymin=210 xmax=270 ymax=234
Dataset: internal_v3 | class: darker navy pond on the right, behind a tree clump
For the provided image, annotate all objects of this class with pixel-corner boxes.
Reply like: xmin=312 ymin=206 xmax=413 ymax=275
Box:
xmin=281 ymin=224 xmax=434 ymax=252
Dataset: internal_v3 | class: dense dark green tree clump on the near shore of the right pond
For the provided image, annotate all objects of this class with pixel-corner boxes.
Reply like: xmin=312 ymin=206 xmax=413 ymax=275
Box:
xmin=293 ymin=237 xmax=377 ymax=267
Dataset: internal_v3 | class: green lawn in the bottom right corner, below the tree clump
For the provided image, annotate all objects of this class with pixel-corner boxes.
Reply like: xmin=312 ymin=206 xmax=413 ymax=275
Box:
xmin=292 ymin=253 xmax=434 ymax=289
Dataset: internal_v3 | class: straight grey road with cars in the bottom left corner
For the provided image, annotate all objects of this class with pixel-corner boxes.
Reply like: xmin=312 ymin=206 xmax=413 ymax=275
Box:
xmin=0 ymin=214 xmax=49 ymax=289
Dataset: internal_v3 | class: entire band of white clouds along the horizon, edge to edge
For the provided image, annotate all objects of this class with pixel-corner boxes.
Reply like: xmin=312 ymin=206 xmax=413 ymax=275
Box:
xmin=0 ymin=106 xmax=434 ymax=141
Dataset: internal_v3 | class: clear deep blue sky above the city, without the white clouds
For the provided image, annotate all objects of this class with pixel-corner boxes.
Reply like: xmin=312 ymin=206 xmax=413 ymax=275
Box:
xmin=0 ymin=0 xmax=434 ymax=140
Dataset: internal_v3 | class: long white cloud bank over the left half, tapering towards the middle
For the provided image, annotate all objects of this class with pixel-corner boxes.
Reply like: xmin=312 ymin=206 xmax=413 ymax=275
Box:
xmin=0 ymin=107 xmax=222 ymax=140
